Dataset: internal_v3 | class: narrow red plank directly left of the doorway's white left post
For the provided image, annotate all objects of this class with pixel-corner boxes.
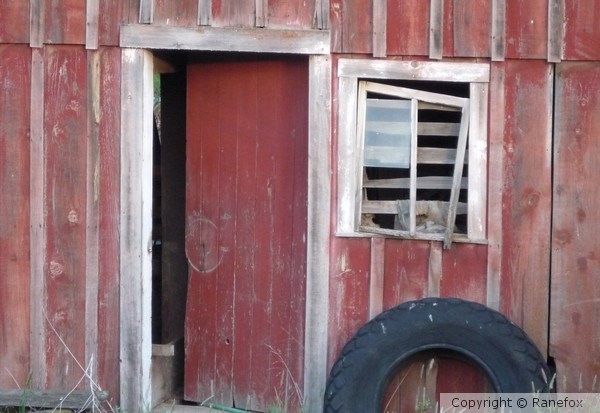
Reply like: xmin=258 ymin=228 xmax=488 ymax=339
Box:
xmin=93 ymin=47 xmax=121 ymax=400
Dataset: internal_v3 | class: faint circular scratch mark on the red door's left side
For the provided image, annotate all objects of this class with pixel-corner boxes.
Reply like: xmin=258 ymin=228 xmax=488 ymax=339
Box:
xmin=185 ymin=213 xmax=226 ymax=273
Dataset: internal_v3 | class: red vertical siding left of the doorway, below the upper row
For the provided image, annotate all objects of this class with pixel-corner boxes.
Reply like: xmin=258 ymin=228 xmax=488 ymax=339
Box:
xmin=0 ymin=44 xmax=120 ymax=397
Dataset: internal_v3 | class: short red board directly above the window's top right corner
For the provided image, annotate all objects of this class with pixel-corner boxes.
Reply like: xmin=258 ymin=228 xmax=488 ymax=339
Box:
xmin=452 ymin=0 xmax=492 ymax=57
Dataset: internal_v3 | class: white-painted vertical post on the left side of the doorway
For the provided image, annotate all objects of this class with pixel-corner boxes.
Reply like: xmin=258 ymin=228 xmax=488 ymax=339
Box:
xmin=119 ymin=49 xmax=153 ymax=412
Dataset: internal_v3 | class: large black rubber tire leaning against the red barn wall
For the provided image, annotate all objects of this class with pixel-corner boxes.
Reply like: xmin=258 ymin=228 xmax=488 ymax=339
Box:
xmin=324 ymin=298 xmax=551 ymax=413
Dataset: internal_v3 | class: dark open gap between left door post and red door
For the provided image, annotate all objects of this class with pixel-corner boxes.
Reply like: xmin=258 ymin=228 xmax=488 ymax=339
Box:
xmin=151 ymin=56 xmax=188 ymax=405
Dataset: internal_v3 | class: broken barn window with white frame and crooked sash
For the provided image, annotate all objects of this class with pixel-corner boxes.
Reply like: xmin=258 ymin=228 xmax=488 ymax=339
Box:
xmin=337 ymin=59 xmax=489 ymax=248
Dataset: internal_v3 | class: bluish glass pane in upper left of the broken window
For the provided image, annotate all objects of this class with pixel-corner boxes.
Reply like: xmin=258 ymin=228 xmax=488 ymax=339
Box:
xmin=363 ymin=98 xmax=411 ymax=168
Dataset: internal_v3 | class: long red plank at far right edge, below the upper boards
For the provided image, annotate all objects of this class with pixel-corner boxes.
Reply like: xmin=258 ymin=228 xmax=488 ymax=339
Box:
xmin=550 ymin=62 xmax=600 ymax=392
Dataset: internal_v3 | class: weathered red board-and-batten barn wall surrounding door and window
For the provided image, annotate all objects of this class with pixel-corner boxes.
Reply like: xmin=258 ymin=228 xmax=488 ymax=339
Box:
xmin=0 ymin=0 xmax=600 ymax=406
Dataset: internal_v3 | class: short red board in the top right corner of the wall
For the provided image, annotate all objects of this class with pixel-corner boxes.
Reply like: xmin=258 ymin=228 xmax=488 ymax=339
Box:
xmin=564 ymin=1 xmax=600 ymax=60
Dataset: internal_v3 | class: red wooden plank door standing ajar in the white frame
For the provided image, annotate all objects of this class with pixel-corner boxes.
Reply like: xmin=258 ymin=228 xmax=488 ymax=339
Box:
xmin=184 ymin=58 xmax=308 ymax=411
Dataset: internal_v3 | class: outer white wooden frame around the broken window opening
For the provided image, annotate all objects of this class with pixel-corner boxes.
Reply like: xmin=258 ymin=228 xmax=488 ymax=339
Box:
xmin=336 ymin=59 xmax=490 ymax=248
